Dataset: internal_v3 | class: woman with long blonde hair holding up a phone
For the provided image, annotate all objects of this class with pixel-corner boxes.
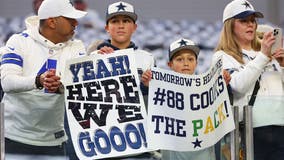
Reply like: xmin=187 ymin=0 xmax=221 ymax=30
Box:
xmin=213 ymin=0 xmax=284 ymax=160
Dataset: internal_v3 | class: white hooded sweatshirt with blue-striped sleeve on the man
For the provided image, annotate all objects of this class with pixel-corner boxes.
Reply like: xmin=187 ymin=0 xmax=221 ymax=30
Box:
xmin=1 ymin=16 xmax=86 ymax=146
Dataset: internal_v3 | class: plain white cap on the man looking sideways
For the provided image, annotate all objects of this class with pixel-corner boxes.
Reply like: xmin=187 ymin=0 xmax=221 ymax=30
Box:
xmin=38 ymin=0 xmax=87 ymax=19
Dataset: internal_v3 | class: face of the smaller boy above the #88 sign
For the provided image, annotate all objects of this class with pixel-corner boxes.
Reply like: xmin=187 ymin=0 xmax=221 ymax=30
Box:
xmin=168 ymin=49 xmax=197 ymax=74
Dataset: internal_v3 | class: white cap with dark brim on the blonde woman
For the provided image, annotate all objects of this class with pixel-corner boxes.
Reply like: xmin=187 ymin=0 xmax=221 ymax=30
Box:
xmin=223 ymin=0 xmax=263 ymax=23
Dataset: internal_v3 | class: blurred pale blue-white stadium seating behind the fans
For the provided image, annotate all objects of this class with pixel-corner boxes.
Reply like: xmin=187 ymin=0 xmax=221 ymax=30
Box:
xmin=0 ymin=0 xmax=274 ymax=73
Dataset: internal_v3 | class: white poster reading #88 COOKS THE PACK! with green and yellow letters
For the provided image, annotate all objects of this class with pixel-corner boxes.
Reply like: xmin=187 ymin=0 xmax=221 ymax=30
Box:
xmin=147 ymin=59 xmax=235 ymax=151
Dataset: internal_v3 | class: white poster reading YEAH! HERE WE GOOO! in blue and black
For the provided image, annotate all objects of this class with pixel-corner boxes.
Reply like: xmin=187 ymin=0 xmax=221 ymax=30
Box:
xmin=62 ymin=49 xmax=147 ymax=160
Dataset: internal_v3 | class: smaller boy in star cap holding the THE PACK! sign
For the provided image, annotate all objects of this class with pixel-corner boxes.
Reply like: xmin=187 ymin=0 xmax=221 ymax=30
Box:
xmin=141 ymin=38 xmax=230 ymax=160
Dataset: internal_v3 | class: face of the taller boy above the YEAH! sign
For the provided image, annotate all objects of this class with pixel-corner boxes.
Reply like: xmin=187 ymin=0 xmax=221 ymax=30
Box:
xmin=105 ymin=15 xmax=137 ymax=46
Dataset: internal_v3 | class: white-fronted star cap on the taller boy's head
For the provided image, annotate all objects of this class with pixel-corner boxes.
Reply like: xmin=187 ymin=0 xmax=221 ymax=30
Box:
xmin=106 ymin=1 xmax=137 ymax=22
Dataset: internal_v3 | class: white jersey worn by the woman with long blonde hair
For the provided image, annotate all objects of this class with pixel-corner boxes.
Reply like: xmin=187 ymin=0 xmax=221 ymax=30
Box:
xmin=213 ymin=50 xmax=284 ymax=127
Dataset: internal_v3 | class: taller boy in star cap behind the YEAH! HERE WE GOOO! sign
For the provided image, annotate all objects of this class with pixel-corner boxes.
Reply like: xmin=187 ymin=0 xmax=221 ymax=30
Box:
xmin=89 ymin=1 xmax=156 ymax=160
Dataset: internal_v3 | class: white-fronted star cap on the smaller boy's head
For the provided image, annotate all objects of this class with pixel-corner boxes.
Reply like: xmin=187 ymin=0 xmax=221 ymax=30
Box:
xmin=169 ymin=38 xmax=200 ymax=60
